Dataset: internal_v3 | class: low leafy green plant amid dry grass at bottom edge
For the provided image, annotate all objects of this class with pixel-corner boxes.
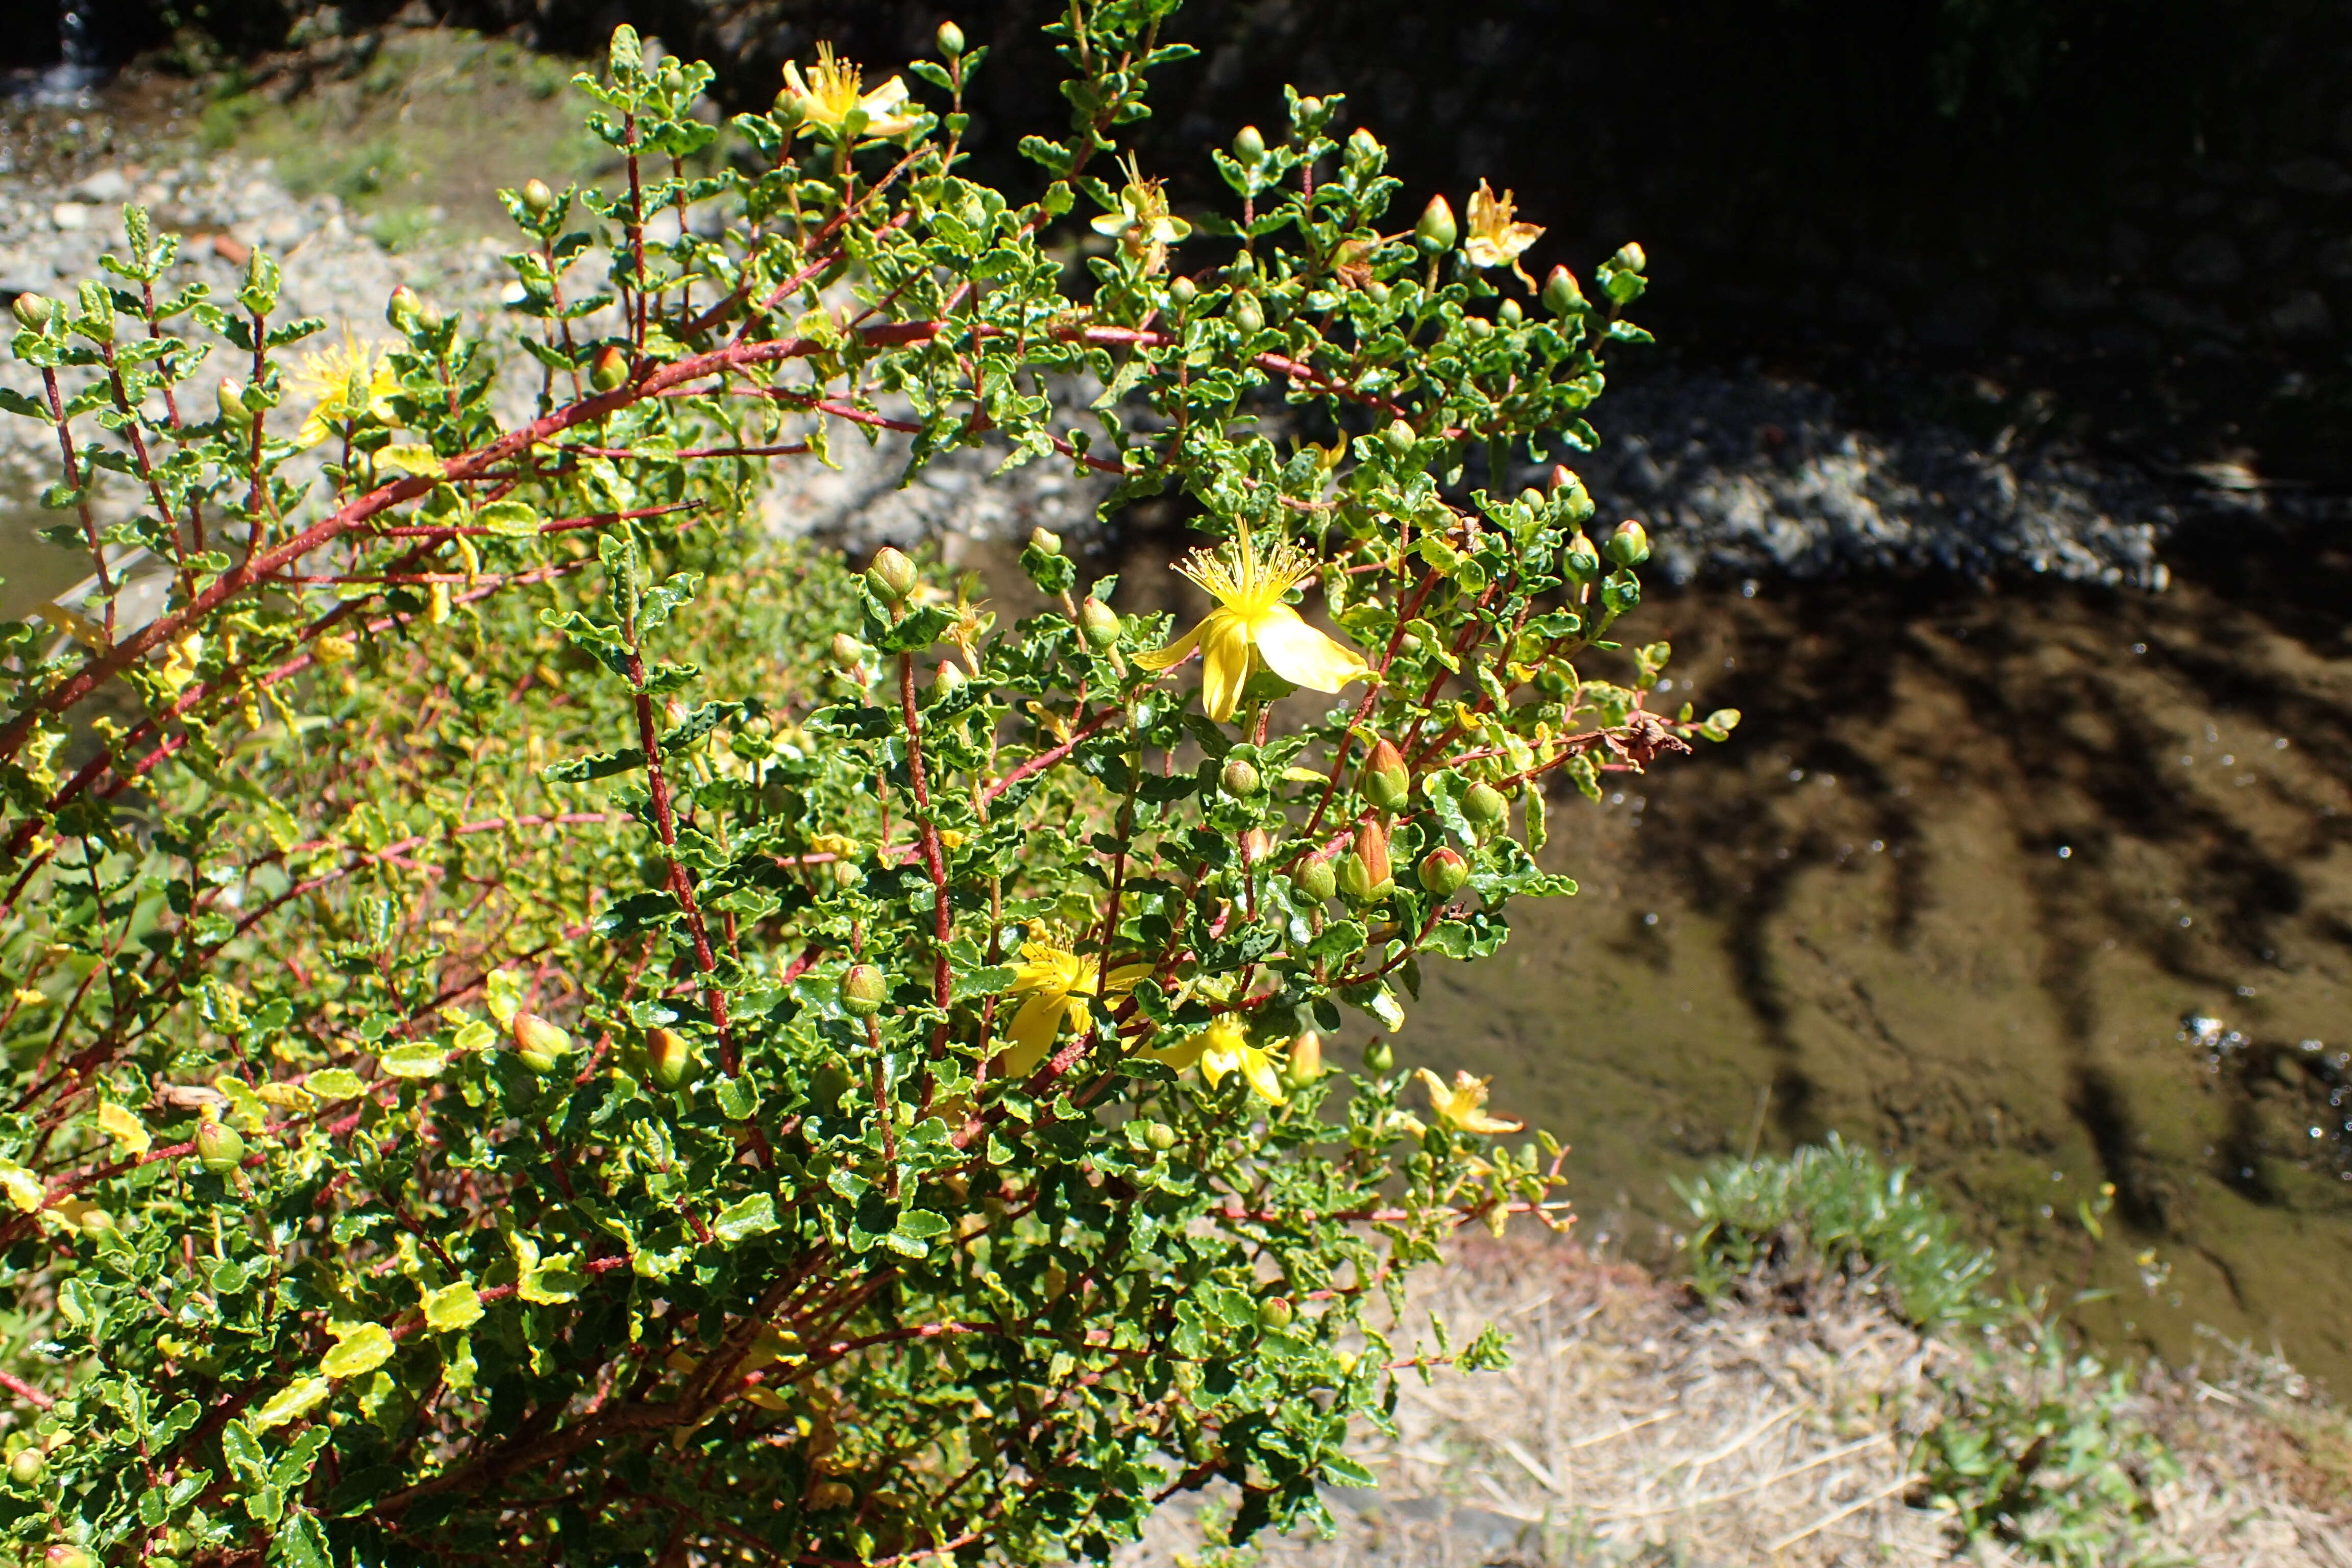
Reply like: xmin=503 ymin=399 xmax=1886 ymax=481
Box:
xmin=1915 ymin=1309 xmax=2180 ymax=1568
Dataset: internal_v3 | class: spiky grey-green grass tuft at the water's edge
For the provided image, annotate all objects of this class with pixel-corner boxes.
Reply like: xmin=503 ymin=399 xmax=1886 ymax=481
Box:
xmin=1675 ymin=1133 xmax=1999 ymax=1328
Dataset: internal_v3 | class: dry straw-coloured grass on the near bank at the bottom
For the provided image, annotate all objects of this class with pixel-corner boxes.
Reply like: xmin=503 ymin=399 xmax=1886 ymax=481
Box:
xmin=1124 ymin=1246 xmax=2352 ymax=1568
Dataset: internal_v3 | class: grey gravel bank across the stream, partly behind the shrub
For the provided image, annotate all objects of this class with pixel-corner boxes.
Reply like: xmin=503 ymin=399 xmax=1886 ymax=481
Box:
xmin=0 ymin=158 xmax=2258 ymax=587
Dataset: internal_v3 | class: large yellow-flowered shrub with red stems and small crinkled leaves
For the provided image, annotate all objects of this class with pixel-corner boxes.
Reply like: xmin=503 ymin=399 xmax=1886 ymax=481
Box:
xmin=0 ymin=0 xmax=1736 ymax=1568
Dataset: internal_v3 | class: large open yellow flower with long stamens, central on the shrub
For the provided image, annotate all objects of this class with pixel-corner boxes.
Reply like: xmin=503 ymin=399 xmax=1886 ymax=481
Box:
xmin=1136 ymin=522 xmax=1371 ymax=724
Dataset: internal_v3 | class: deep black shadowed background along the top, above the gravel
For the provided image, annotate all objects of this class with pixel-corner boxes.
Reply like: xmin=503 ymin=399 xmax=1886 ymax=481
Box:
xmin=5 ymin=0 xmax=2352 ymax=486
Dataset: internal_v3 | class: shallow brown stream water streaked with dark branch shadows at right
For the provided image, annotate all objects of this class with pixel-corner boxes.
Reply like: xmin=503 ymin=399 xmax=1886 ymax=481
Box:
xmin=1400 ymin=536 xmax=2352 ymax=1389
